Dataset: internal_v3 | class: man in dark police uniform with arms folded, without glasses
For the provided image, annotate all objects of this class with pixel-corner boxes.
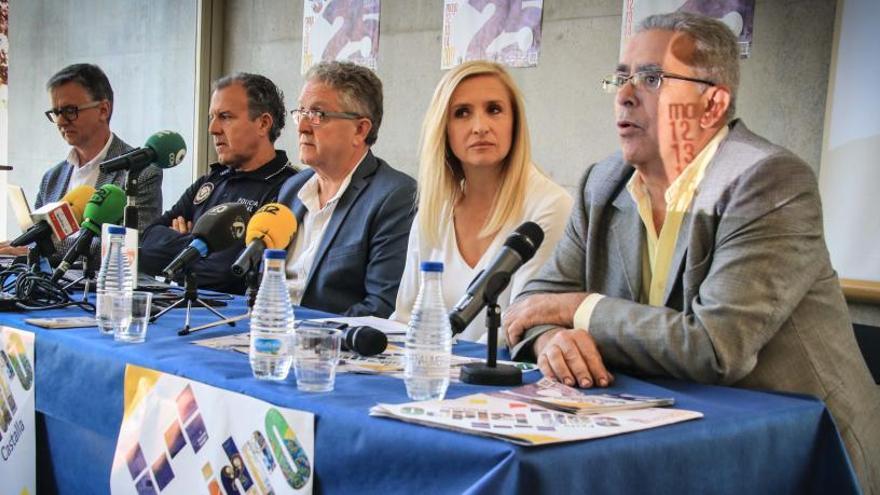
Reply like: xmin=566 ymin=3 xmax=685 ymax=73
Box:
xmin=139 ymin=73 xmax=296 ymax=294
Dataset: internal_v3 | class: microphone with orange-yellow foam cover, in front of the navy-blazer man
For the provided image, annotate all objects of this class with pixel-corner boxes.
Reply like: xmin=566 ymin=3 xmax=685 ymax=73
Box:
xmin=232 ymin=203 xmax=296 ymax=277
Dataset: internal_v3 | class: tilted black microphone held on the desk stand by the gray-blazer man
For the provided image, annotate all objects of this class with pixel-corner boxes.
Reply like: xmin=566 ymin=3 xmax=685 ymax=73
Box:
xmin=449 ymin=222 xmax=544 ymax=335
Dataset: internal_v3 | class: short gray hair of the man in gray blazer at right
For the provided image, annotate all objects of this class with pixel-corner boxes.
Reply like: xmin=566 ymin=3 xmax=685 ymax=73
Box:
xmin=636 ymin=12 xmax=739 ymax=122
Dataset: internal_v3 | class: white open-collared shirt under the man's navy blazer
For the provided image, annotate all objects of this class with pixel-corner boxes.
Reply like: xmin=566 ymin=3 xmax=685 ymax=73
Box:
xmin=287 ymin=151 xmax=369 ymax=305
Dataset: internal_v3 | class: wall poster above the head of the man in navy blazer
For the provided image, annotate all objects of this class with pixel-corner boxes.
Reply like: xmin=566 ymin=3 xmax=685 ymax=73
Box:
xmin=300 ymin=0 xmax=379 ymax=74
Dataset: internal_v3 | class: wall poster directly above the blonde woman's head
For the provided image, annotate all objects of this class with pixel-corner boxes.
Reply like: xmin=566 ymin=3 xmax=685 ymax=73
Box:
xmin=440 ymin=0 xmax=544 ymax=70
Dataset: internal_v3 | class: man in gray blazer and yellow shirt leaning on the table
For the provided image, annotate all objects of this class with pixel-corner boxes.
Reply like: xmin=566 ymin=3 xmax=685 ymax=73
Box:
xmin=503 ymin=13 xmax=880 ymax=492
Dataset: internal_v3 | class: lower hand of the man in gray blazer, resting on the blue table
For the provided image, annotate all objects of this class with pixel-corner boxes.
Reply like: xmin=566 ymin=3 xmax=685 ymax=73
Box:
xmin=535 ymin=328 xmax=614 ymax=388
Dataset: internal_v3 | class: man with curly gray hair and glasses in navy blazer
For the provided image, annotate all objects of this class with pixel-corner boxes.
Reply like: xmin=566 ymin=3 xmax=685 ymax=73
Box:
xmin=279 ymin=62 xmax=416 ymax=318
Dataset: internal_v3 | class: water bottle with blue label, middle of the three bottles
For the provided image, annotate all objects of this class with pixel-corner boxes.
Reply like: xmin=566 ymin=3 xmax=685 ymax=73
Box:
xmin=250 ymin=249 xmax=293 ymax=381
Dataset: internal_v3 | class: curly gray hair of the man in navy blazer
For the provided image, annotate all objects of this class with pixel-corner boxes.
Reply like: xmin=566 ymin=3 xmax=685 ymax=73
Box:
xmin=305 ymin=61 xmax=382 ymax=145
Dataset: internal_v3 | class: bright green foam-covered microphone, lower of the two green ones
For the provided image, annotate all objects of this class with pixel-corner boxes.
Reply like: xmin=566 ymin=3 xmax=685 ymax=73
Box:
xmin=52 ymin=184 xmax=125 ymax=282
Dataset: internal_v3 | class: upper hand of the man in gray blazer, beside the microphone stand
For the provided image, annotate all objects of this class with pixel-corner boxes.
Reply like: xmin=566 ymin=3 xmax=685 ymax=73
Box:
xmin=501 ymin=292 xmax=587 ymax=347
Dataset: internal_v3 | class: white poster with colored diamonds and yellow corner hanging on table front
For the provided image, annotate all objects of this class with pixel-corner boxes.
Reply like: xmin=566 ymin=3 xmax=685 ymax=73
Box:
xmin=110 ymin=365 xmax=315 ymax=495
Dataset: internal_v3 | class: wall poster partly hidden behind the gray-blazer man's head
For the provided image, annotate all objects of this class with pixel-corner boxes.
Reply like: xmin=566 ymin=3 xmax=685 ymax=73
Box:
xmin=620 ymin=0 xmax=755 ymax=58
